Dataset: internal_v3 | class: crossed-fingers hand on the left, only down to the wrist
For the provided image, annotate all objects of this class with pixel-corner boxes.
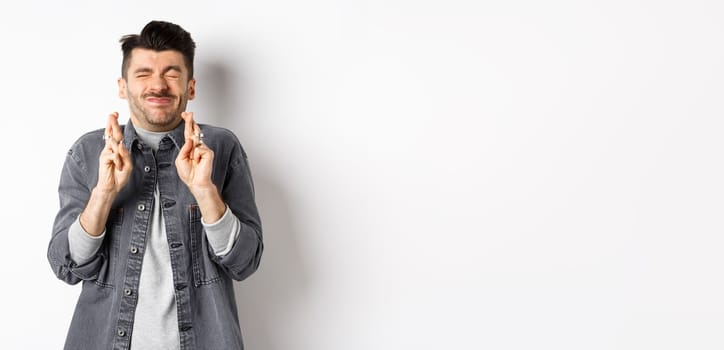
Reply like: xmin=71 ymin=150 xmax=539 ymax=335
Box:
xmin=96 ymin=112 xmax=133 ymax=195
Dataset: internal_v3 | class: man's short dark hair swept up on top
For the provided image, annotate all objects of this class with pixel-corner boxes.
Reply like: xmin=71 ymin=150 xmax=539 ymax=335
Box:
xmin=120 ymin=21 xmax=196 ymax=79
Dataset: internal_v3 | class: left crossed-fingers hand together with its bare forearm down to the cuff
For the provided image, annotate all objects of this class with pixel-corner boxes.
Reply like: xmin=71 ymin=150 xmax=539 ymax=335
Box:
xmin=79 ymin=112 xmax=133 ymax=236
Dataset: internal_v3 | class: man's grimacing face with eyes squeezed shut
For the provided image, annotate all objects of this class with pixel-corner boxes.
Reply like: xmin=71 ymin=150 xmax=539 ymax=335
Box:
xmin=118 ymin=49 xmax=196 ymax=131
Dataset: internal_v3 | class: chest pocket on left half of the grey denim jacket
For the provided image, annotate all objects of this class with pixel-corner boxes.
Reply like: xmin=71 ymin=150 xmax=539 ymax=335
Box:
xmin=95 ymin=208 xmax=123 ymax=288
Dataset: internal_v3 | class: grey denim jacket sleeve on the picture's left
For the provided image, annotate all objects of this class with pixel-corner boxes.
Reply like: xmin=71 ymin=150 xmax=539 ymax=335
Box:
xmin=48 ymin=144 xmax=103 ymax=284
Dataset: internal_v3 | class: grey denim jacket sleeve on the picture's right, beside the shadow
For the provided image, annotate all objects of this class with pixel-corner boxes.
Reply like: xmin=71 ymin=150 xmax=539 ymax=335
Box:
xmin=208 ymin=137 xmax=264 ymax=281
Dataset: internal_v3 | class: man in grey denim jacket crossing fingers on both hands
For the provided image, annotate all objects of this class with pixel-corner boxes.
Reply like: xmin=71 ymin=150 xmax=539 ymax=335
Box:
xmin=48 ymin=21 xmax=263 ymax=350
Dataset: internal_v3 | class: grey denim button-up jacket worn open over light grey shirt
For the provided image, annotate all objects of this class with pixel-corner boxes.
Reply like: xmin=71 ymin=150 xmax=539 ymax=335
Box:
xmin=48 ymin=122 xmax=263 ymax=350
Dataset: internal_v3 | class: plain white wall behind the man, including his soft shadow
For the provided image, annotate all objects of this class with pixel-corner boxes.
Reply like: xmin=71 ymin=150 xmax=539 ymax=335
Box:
xmin=0 ymin=0 xmax=724 ymax=350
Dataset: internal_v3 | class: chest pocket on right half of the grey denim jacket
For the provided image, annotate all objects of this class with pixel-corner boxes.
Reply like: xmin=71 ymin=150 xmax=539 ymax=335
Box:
xmin=189 ymin=205 xmax=221 ymax=287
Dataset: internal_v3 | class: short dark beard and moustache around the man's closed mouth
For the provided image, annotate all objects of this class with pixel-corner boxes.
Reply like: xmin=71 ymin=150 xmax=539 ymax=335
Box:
xmin=127 ymin=91 xmax=188 ymax=131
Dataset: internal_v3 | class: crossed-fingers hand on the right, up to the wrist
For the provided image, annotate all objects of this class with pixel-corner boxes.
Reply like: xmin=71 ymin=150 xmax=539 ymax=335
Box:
xmin=176 ymin=112 xmax=216 ymax=193
